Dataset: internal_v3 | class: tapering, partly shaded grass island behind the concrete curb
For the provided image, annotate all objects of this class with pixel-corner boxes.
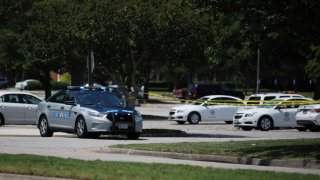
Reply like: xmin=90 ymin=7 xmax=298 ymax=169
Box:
xmin=111 ymin=138 xmax=320 ymax=160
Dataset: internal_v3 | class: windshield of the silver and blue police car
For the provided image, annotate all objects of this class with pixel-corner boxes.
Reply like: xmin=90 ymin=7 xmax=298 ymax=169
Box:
xmin=77 ymin=92 xmax=123 ymax=107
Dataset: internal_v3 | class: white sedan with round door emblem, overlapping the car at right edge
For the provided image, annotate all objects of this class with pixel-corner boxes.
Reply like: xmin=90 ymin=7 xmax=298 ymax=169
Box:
xmin=233 ymin=98 xmax=310 ymax=131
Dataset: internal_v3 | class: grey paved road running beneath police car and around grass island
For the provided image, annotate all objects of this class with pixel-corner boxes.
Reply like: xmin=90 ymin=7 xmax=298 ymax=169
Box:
xmin=0 ymin=120 xmax=320 ymax=175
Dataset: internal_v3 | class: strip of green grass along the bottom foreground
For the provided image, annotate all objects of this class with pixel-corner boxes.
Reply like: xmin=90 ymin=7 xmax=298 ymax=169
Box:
xmin=0 ymin=154 xmax=320 ymax=180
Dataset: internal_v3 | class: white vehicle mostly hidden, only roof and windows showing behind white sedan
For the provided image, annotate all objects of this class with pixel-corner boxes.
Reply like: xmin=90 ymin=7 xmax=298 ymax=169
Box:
xmin=247 ymin=93 xmax=305 ymax=105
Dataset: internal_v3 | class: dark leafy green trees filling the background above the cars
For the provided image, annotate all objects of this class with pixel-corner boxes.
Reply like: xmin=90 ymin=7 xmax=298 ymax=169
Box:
xmin=0 ymin=0 xmax=320 ymax=104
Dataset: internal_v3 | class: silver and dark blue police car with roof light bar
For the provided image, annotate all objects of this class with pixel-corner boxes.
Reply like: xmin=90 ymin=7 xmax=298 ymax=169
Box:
xmin=36 ymin=87 xmax=142 ymax=139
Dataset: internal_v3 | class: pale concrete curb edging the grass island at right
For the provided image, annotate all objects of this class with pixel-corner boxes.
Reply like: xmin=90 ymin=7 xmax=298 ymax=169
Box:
xmin=94 ymin=147 xmax=320 ymax=169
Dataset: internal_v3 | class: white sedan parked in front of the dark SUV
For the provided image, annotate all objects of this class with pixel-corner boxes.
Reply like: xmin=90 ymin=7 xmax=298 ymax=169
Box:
xmin=169 ymin=95 xmax=245 ymax=124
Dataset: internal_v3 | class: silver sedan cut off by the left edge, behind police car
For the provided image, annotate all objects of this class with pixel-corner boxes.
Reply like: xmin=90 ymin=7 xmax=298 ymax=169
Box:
xmin=0 ymin=91 xmax=43 ymax=125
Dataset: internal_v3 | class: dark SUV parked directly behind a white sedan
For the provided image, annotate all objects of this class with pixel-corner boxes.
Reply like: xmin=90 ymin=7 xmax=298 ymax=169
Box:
xmin=187 ymin=84 xmax=245 ymax=99
